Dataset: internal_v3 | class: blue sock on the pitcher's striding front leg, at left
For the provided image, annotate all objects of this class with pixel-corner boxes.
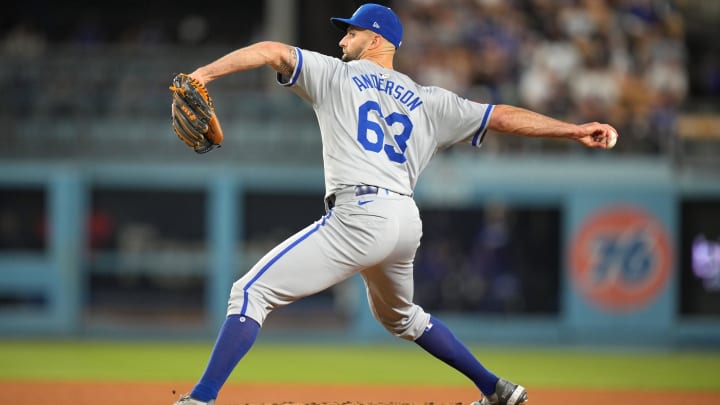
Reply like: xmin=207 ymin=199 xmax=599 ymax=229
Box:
xmin=190 ymin=315 xmax=260 ymax=402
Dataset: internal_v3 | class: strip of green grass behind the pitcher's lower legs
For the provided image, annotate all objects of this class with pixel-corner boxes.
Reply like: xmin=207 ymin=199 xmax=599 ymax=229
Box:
xmin=0 ymin=340 xmax=720 ymax=391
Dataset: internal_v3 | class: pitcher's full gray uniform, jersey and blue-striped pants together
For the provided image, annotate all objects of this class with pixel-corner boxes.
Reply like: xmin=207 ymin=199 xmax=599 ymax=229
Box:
xmin=228 ymin=48 xmax=493 ymax=340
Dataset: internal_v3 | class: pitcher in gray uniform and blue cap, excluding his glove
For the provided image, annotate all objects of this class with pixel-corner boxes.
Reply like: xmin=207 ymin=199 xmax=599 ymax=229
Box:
xmin=175 ymin=4 xmax=616 ymax=405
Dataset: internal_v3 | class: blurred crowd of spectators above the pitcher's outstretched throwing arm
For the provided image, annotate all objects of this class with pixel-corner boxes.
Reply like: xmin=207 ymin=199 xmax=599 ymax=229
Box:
xmin=394 ymin=0 xmax=689 ymax=153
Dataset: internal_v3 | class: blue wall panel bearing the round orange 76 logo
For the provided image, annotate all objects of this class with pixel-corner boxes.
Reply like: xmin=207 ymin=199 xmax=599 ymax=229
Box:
xmin=563 ymin=190 xmax=678 ymax=342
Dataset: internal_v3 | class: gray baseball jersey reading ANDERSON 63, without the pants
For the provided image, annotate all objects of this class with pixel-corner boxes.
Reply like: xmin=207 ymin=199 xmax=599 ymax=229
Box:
xmin=284 ymin=49 xmax=492 ymax=195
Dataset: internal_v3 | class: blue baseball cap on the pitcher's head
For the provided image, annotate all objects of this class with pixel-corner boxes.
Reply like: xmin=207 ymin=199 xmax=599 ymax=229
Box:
xmin=330 ymin=3 xmax=402 ymax=48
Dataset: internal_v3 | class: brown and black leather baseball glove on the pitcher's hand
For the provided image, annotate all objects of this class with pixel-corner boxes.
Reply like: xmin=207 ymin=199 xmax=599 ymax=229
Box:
xmin=170 ymin=73 xmax=223 ymax=153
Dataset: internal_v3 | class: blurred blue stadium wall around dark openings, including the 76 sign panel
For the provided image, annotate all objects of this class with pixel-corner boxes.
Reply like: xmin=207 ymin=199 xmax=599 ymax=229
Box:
xmin=0 ymin=154 xmax=720 ymax=347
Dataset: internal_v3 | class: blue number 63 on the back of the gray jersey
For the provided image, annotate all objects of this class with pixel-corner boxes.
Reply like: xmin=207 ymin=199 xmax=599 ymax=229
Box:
xmin=357 ymin=100 xmax=413 ymax=163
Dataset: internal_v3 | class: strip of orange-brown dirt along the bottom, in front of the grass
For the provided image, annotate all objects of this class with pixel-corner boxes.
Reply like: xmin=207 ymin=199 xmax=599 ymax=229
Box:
xmin=0 ymin=380 xmax=720 ymax=405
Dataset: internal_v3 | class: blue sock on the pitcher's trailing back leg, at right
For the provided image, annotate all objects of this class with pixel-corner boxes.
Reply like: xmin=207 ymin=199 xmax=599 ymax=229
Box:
xmin=415 ymin=316 xmax=498 ymax=395
